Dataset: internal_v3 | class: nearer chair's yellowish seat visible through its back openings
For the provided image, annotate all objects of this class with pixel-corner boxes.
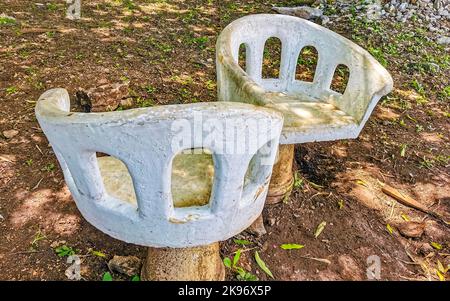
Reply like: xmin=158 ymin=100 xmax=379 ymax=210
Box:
xmin=98 ymin=153 xmax=214 ymax=208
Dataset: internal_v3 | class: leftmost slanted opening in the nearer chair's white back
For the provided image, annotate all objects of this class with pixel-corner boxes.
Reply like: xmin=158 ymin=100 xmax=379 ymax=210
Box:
xmin=97 ymin=153 xmax=138 ymax=209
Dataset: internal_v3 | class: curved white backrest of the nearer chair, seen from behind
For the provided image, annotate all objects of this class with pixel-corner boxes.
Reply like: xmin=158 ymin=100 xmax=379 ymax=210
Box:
xmin=36 ymin=89 xmax=283 ymax=247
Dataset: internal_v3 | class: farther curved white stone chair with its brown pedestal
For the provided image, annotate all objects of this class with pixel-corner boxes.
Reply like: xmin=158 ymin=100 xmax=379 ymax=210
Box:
xmin=216 ymin=14 xmax=393 ymax=202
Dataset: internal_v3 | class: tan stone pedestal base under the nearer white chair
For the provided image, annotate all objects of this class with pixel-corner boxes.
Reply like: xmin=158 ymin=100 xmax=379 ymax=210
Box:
xmin=141 ymin=242 xmax=225 ymax=281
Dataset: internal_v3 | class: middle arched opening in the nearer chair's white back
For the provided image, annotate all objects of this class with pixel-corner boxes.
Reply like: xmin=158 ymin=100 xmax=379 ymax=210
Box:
xmin=171 ymin=148 xmax=214 ymax=208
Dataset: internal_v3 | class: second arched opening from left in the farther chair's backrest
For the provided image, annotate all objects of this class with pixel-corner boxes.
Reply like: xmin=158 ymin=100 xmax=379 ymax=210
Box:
xmin=262 ymin=37 xmax=282 ymax=78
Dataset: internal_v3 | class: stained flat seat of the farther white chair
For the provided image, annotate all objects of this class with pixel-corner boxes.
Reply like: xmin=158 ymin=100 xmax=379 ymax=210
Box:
xmin=266 ymin=92 xmax=358 ymax=144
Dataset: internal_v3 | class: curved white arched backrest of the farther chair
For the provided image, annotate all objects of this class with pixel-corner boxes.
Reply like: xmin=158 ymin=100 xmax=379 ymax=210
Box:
xmin=216 ymin=14 xmax=393 ymax=122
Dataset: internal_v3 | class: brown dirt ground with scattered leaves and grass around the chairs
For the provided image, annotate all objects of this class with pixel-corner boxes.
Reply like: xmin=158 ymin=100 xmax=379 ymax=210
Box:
xmin=0 ymin=0 xmax=450 ymax=280
